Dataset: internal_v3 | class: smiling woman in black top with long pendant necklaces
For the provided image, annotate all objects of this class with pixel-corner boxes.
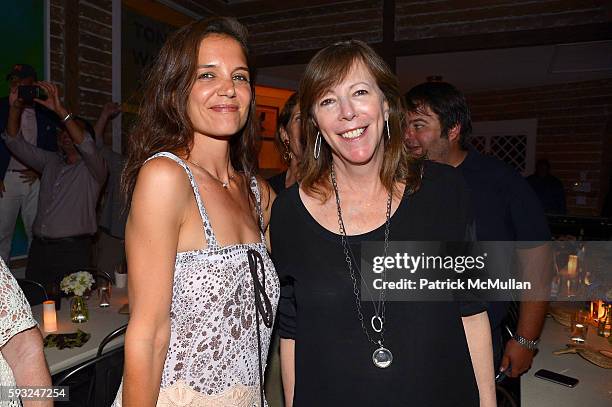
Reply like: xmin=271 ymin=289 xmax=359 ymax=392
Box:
xmin=271 ymin=41 xmax=495 ymax=407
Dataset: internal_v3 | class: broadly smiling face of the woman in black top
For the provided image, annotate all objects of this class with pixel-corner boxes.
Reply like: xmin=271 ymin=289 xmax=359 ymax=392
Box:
xmin=313 ymin=61 xmax=389 ymax=165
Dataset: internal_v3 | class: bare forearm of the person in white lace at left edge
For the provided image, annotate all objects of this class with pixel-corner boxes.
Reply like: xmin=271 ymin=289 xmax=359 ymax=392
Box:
xmin=1 ymin=327 xmax=53 ymax=407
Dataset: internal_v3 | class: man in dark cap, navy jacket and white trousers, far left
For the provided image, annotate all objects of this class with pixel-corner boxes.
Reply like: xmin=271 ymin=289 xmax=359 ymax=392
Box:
xmin=0 ymin=64 xmax=59 ymax=265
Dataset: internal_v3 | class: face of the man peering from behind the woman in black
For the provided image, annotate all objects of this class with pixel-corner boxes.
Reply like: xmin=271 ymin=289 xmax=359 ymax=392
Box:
xmin=406 ymin=106 xmax=450 ymax=163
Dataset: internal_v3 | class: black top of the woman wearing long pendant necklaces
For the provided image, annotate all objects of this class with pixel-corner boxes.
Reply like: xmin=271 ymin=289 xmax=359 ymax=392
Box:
xmin=270 ymin=162 xmax=486 ymax=407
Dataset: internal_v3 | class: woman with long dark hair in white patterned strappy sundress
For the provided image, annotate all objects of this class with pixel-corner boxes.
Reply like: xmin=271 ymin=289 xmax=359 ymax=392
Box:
xmin=115 ymin=18 xmax=280 ymax=407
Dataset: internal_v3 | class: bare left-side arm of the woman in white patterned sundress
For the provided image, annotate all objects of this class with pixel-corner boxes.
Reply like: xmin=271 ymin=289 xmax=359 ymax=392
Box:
xmin=123 ymin=159 xmax=189 ymax=407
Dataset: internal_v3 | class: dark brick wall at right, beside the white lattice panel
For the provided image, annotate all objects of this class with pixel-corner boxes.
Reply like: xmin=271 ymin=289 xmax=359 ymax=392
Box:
xmin=468 ymin=80 xmax=612 ymax=216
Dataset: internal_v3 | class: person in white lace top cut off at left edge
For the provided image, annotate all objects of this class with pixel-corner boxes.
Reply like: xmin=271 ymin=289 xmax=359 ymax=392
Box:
xmin=0 ymin=258 xmax=53 ymax=407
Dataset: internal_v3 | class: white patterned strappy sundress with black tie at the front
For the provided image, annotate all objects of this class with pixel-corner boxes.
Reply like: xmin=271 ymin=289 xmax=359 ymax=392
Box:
xmin=113 ymin=153 xmax=280 ymax=407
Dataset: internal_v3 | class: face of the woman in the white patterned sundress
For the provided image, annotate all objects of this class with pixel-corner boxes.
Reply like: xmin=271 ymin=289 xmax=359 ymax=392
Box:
xmin=187 ymin=34 xmax=252 ymax=138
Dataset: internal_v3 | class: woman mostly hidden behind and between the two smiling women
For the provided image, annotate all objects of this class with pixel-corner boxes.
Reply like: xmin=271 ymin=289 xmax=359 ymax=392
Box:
xmin=268 ymin=93 xmax=302 ymax=195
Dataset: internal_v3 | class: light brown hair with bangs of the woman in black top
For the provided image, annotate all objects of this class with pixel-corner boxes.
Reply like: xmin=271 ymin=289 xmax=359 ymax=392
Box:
xmin=300 ymin=40 xmax=422 ymax=201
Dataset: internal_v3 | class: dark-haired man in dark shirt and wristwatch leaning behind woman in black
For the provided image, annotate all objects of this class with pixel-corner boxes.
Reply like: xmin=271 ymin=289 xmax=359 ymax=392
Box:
xmin=405 ymin=82 xmax=551 ymax=388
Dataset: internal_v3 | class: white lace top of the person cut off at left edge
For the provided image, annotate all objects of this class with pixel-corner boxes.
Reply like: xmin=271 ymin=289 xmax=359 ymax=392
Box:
xmin=0 ymin=258 xmax=36 ymax=407
